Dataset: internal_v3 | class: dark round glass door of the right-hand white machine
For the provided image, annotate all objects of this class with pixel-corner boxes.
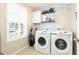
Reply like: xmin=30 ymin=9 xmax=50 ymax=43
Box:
xmin=55 ymin=38 xmax=67 ymax=50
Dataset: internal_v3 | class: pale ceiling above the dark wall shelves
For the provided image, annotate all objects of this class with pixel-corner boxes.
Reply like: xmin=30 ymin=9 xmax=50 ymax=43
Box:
xmin=25 ymin=3 xmax=72 ymax=10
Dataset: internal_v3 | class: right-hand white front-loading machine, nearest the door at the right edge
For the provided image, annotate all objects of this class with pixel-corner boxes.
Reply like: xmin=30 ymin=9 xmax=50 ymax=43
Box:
xmin=51 ymin=31 xmax=73 ymax=55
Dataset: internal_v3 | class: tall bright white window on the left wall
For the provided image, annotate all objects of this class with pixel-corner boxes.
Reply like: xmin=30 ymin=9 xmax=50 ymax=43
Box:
xmin=7 ymin=3 xmax=27 ymax=41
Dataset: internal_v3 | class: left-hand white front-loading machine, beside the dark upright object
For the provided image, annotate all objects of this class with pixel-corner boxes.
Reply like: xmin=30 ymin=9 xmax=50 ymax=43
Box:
xmin=34 ymin=30 xmax=50 ymax=54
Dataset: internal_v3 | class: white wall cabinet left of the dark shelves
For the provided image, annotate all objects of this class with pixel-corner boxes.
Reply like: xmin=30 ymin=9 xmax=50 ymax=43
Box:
xmin=32 ymin=11 xmax=41 ymax=23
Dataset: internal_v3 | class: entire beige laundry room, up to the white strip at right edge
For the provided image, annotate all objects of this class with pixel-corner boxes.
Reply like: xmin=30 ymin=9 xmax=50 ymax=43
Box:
xmin=0 ymin=3 xmax=77 ymax=55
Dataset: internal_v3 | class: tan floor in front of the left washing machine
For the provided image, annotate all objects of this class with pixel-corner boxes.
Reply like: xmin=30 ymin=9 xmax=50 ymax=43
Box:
xmin=16 ymin=47 xmax=44 ymax=55
